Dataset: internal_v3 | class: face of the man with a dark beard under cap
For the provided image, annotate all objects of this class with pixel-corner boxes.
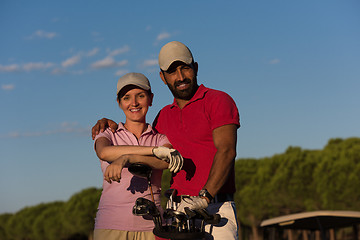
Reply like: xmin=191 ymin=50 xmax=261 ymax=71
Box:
xmin=160 ymin=62 xmax=198 ymax=100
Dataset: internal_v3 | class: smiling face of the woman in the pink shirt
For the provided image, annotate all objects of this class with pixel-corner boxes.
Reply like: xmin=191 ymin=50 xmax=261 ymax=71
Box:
xmin=118 ymin=88 xmax=153 ymax=123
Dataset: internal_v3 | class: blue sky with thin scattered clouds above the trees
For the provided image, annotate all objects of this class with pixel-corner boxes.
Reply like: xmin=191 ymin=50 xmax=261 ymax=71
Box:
xmin=0 ymin=0 xmax=360 ymax=213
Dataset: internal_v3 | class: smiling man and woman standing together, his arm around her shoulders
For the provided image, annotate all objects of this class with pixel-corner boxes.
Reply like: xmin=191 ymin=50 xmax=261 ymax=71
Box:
xmin=92 ymin=41 xmax=240 ymax=240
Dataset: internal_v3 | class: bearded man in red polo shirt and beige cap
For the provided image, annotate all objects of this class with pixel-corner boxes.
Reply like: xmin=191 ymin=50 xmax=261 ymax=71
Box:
xmin=92 ymin=41 xmax=240 ymax=239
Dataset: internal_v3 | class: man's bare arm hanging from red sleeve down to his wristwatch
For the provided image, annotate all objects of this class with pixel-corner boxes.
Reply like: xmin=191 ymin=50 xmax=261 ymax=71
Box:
xmin=203 ymin=124 xmax=237 ymax=201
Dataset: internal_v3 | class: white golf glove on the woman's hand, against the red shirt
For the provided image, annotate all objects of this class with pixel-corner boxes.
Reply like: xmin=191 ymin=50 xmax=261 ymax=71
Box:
xmin=152 ymin=146 xmax=184 ymax=173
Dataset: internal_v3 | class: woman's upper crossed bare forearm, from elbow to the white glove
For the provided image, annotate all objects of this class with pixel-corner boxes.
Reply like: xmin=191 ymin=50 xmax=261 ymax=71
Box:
xmin=95 ymin=137 xmax=172 ymax=162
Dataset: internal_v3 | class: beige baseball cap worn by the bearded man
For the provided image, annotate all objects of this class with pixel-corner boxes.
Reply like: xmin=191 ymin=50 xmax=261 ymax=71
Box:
xmin=159 ymin=41 xmax=194 ymax=71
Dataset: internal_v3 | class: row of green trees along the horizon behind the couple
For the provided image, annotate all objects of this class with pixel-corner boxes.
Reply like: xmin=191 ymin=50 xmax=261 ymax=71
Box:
xmin=0 ymin=138 xmax=360 ymax=240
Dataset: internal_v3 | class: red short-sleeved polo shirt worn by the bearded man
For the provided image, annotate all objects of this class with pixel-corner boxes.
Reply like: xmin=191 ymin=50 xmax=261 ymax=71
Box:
xmin=154 ymin=85 xmax=240 ymax=196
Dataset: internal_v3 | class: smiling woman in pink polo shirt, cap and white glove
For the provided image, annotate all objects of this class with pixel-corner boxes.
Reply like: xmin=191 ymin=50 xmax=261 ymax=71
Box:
xmin=94 ymin=73 xmax=183 ymax=240
